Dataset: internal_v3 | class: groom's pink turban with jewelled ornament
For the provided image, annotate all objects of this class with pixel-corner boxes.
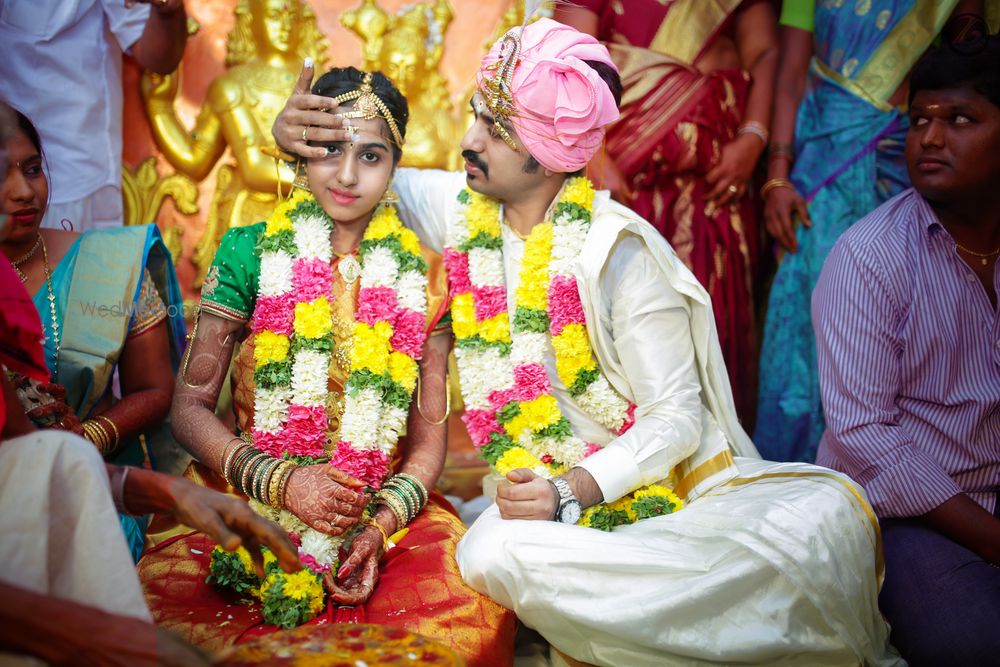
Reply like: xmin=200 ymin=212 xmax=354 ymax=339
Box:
xmin=479 ymin=18 xmax=618 ymax=173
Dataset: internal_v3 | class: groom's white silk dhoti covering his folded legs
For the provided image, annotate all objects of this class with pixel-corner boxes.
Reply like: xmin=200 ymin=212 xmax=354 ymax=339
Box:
xmin=457 ymin=458 xmax=903 ymax=667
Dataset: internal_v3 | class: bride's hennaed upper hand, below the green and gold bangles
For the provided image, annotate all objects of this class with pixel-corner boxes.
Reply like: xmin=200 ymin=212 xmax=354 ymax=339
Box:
xmin=285 ymin=463 xmax=369 ymax=535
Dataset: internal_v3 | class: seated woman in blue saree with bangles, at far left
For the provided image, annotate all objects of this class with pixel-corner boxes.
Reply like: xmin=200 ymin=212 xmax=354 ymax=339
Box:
xmin=0 ymin=107 xmax=184 ymax=560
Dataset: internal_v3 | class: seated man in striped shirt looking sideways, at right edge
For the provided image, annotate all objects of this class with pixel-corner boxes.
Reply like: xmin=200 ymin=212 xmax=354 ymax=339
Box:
xmin=812 ymin=38 xmax=1000 ymax=665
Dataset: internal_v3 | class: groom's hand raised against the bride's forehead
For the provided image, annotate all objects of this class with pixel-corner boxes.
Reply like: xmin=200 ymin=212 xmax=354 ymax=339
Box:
xmin=271 ymin=60 xmax=351 ymax=158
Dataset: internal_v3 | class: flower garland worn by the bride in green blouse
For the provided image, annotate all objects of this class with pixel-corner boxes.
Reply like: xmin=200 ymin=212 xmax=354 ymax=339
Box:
xmin=212 ymin=190 xmax=427 ymax=627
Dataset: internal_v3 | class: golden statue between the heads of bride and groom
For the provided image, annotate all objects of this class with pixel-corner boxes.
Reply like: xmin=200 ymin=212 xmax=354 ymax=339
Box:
xmin=340 ymin=0 xmax=465 ymax=169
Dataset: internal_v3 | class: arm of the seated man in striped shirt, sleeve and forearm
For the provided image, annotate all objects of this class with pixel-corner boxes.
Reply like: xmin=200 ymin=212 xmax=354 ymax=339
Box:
xmin=812 ymin=238 xmax=1000 ymax=562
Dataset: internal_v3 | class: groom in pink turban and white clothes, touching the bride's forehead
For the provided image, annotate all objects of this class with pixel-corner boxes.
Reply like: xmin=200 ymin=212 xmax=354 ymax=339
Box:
xmin=273 ymin=19 xmax=897 ymax=665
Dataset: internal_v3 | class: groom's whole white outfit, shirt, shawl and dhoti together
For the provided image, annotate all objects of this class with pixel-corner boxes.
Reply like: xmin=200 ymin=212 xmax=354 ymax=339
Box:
xmin=396 ymin=170 xmax=898 ymax=667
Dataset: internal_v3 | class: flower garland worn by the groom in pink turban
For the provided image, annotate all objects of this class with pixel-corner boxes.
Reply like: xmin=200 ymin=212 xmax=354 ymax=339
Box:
xmin=444 ymin=177 xmax=683 ymax=530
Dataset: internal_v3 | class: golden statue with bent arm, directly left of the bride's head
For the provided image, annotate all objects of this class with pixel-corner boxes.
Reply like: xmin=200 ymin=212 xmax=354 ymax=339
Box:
xmin=142 ymin=0 xmax=327 ymax=288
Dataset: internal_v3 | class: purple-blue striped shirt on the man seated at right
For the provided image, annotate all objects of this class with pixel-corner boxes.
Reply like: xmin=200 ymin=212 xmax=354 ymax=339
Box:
xmin=812 ymin=189 xmax=1000 ymax=517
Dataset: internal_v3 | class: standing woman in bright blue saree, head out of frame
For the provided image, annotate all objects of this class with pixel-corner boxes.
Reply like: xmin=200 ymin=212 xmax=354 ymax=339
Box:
xmin=754 ymin=0 xmax=982 ymax=462
